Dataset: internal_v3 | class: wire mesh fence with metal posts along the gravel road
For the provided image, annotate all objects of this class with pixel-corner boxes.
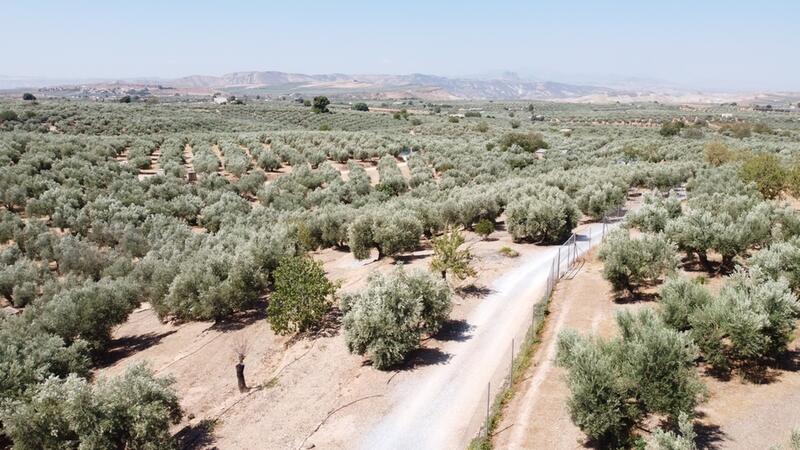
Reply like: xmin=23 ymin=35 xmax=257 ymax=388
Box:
xmin=478 ymin=208 xmax=626 ymax=439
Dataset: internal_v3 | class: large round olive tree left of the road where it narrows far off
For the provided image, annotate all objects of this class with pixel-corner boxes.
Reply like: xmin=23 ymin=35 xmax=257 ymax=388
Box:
xmin=506 ymin=186 xmax=580 ymax=243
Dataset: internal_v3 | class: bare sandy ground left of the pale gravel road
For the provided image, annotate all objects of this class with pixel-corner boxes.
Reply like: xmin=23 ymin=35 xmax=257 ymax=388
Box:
xmin=98 ymin=220 xmax=547 ymax=449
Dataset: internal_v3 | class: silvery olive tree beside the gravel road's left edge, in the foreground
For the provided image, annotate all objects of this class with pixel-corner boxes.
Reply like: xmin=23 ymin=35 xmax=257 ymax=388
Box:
xmin=342 ymin=268 xmax=452 ymax=369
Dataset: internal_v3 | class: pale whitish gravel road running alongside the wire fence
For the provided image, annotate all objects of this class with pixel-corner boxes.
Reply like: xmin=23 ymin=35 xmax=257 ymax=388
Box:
xmin=359 ymin=219 xmax=628 ymax=449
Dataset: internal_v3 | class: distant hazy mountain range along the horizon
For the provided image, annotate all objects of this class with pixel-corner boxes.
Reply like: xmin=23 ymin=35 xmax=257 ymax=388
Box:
xmin=0 ymin=71 xmax=800 ymax=104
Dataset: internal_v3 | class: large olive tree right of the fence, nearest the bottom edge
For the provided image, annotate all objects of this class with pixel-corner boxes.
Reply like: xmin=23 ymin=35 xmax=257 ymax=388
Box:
xmin=557 ymin=310 xmax=704 ymax=447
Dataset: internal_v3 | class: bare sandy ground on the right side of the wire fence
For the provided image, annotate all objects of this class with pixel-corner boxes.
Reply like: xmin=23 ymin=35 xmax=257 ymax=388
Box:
xmin=494 ymin=258 xmax=800 ymax=449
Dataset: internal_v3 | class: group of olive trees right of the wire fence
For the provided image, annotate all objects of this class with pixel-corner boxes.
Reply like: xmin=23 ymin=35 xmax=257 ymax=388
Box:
xmin=558 ymin=179 xmax=800 ymax=448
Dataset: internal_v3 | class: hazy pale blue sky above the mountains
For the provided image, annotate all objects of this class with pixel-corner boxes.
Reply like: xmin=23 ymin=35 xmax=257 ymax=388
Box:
xmin=0 ymin=0 xmax=800 ymax=91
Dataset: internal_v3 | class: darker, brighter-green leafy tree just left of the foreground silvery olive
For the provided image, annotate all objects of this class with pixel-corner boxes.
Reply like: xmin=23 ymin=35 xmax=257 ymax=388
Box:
xmin=267 ymin=257 xmax=336 ymax=334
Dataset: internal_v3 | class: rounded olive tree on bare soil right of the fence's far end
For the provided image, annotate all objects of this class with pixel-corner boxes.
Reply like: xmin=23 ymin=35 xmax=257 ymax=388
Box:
xmin=598 ymin=229 xmax=678 ymax=293
